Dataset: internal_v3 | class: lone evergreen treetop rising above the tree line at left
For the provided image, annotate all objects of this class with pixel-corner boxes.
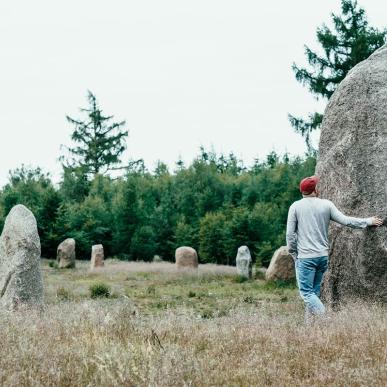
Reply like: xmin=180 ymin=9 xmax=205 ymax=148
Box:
xmin=61 ymin=91 xmax=128 ymax=175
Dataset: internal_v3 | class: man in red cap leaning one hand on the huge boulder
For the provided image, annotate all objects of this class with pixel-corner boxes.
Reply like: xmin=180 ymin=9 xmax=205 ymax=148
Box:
xmin=286 ymin=176 xmax=383 ymax=320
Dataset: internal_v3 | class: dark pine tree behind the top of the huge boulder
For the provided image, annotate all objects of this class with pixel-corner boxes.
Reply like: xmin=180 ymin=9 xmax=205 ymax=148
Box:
xmin=289 ymin=0 xmax=387 ymax=150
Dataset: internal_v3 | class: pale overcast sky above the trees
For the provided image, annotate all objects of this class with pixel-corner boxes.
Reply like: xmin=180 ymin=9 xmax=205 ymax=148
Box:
xmin=0 ymin=0 xmax=387 ymax=186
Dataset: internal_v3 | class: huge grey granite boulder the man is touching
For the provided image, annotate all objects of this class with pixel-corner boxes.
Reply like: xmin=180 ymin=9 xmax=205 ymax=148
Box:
xmin=316 ymin=46 xmax=387 ymax=304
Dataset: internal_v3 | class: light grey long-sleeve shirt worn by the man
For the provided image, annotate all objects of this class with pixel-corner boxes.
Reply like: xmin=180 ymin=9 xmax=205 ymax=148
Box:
xmin=286 ymin=197 xmax=372 ymax=259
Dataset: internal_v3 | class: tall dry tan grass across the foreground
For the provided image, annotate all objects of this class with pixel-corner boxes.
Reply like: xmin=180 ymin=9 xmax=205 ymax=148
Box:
xmin=0 ymin=300 xmax=387 ymax=386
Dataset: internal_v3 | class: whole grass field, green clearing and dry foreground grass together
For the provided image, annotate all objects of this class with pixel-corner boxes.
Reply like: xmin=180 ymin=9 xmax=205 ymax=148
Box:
xmin=0 ymin=260 xmax=387 ymax=386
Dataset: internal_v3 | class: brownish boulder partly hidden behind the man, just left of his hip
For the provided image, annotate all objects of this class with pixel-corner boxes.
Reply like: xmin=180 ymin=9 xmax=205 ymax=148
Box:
xmin=265 ymin=246 xmax=296 ymax=281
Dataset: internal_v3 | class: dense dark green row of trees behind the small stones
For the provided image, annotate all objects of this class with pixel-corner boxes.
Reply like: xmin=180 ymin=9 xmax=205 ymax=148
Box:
xmin=0 ymin=149 xmax=315 ymax=265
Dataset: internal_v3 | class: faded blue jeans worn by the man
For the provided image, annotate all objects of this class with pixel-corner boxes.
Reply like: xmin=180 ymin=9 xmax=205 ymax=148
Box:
xmin=296 ymin=257 xmax=328 ymax=319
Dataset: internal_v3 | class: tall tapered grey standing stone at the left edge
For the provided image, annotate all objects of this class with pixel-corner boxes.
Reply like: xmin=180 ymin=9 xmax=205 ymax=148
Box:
xmin=0 ymin=204 xmax=43 ymax=309
